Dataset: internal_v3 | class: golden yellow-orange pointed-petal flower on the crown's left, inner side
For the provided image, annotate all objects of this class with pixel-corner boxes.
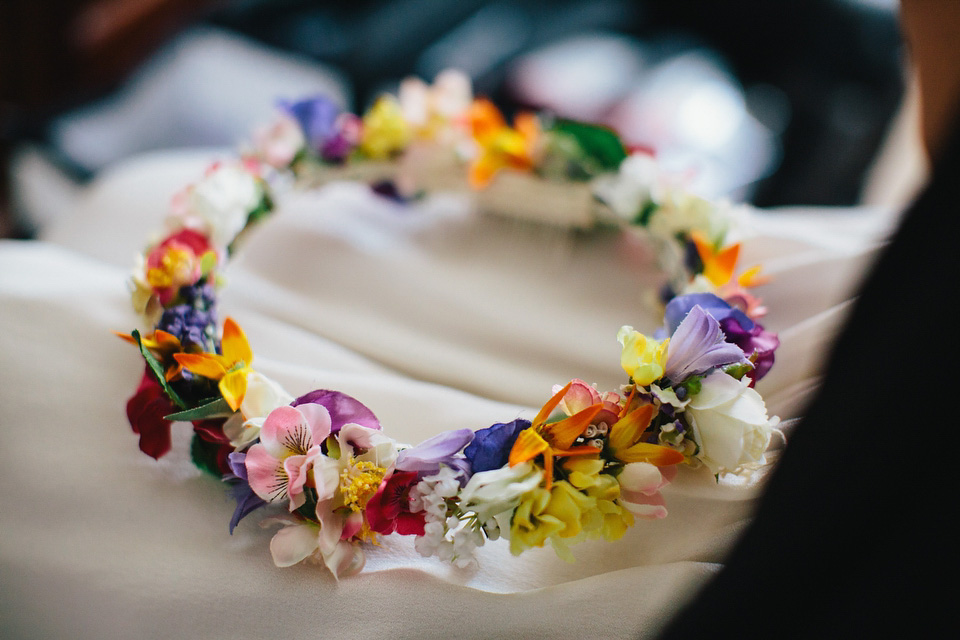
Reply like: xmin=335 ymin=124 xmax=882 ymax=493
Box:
xmin=173 ymin=318 xmax=253 ymax=411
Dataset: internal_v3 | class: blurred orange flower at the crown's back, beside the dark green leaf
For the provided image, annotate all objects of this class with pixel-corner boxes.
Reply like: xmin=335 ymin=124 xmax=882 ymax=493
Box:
xmin=467 ymin=99 xmax=540 ymax=188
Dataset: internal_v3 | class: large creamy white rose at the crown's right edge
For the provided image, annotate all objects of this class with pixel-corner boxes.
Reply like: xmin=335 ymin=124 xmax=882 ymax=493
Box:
xmin=686 ymin=371 xmax=778 ymax=473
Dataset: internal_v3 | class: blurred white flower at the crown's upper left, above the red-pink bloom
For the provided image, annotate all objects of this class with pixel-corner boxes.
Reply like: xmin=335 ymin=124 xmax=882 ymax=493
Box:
xmin=174 ymin=164 xmax=263 ymax=247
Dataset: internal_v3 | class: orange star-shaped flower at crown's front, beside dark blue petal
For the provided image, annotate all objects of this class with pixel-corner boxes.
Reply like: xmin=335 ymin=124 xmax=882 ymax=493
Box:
xmin=508 ymin=382 xmax=603 ymax=489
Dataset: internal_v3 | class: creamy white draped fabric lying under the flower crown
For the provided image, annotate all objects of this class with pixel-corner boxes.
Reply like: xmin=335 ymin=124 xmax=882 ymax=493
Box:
xmin=0 ymin=153 xmax=888 ymax=639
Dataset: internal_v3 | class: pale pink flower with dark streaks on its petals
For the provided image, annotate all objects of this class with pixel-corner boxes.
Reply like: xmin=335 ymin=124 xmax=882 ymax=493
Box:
xmin=245 ymin=404 xmax=337 ymax=511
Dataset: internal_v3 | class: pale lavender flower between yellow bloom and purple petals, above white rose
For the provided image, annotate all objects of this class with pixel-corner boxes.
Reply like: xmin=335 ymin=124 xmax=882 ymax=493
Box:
xmin=665 ymin=305 xmax=747 ymax=383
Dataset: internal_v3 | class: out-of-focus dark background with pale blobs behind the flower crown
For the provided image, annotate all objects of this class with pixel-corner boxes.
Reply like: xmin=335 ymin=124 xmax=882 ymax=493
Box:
xmin=0 ymin=0 xmax=912 ymax=238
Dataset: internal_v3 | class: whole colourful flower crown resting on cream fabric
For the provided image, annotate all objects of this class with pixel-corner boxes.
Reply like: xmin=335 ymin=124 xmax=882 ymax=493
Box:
xmin=119 ymin=72 xmax=779 ymax=576
